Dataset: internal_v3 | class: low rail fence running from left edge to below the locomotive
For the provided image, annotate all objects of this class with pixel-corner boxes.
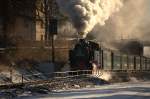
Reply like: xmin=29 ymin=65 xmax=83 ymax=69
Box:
xmin=0 ymin=70 xmax=92 ymax=85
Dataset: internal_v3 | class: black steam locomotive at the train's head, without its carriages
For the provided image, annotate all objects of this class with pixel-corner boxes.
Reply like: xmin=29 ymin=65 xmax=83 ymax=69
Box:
xmin=69 ymin=39 xmax=99 ymax=70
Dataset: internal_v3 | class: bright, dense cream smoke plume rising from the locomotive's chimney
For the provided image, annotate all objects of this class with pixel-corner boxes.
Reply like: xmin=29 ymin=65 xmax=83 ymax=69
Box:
xmin=57 ymin=0 xmax=123 ymax=37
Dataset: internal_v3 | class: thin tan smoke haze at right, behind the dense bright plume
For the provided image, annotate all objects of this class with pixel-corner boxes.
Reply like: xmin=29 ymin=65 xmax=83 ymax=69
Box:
xmin=91 ymin=0 xmax=150 ymax=41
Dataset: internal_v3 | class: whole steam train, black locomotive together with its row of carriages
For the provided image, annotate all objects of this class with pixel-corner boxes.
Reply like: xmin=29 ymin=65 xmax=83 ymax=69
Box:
xmin=69 ymin=39 xmax=150 ymax=71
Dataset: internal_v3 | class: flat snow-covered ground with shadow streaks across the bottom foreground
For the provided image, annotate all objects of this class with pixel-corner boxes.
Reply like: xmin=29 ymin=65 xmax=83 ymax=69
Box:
xmin=15 ymin=81 xmax=150 ymax=99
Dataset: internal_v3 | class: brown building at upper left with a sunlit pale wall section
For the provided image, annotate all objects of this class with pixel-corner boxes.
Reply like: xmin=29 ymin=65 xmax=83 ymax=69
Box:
xmin=0 ymin=0 xmax=51 ymax=42
